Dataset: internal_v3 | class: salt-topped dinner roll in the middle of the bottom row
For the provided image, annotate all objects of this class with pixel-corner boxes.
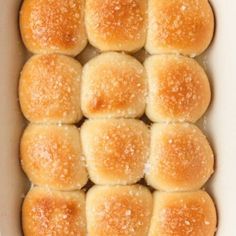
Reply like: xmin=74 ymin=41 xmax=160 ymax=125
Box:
xmin=86 ymin=185 xmax=152 ymax=236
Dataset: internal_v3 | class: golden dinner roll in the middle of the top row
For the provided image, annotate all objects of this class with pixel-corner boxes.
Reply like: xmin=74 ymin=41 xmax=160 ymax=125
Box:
xmin=85 ymin=0 xmax=147 ymax=52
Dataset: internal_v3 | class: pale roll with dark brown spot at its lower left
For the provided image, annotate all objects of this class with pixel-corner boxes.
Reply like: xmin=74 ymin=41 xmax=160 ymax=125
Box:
xmin=81 ymin=52 xmax=147 ymax=118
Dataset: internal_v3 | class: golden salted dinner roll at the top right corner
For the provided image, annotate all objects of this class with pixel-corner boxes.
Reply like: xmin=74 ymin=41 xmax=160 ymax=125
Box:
xmin=146 ymin=0 xmax=214 ymax=56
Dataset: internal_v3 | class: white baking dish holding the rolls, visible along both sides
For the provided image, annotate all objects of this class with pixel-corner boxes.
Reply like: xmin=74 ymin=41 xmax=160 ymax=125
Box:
xmin=0 ymin=0 xmax=236 ymax=236
